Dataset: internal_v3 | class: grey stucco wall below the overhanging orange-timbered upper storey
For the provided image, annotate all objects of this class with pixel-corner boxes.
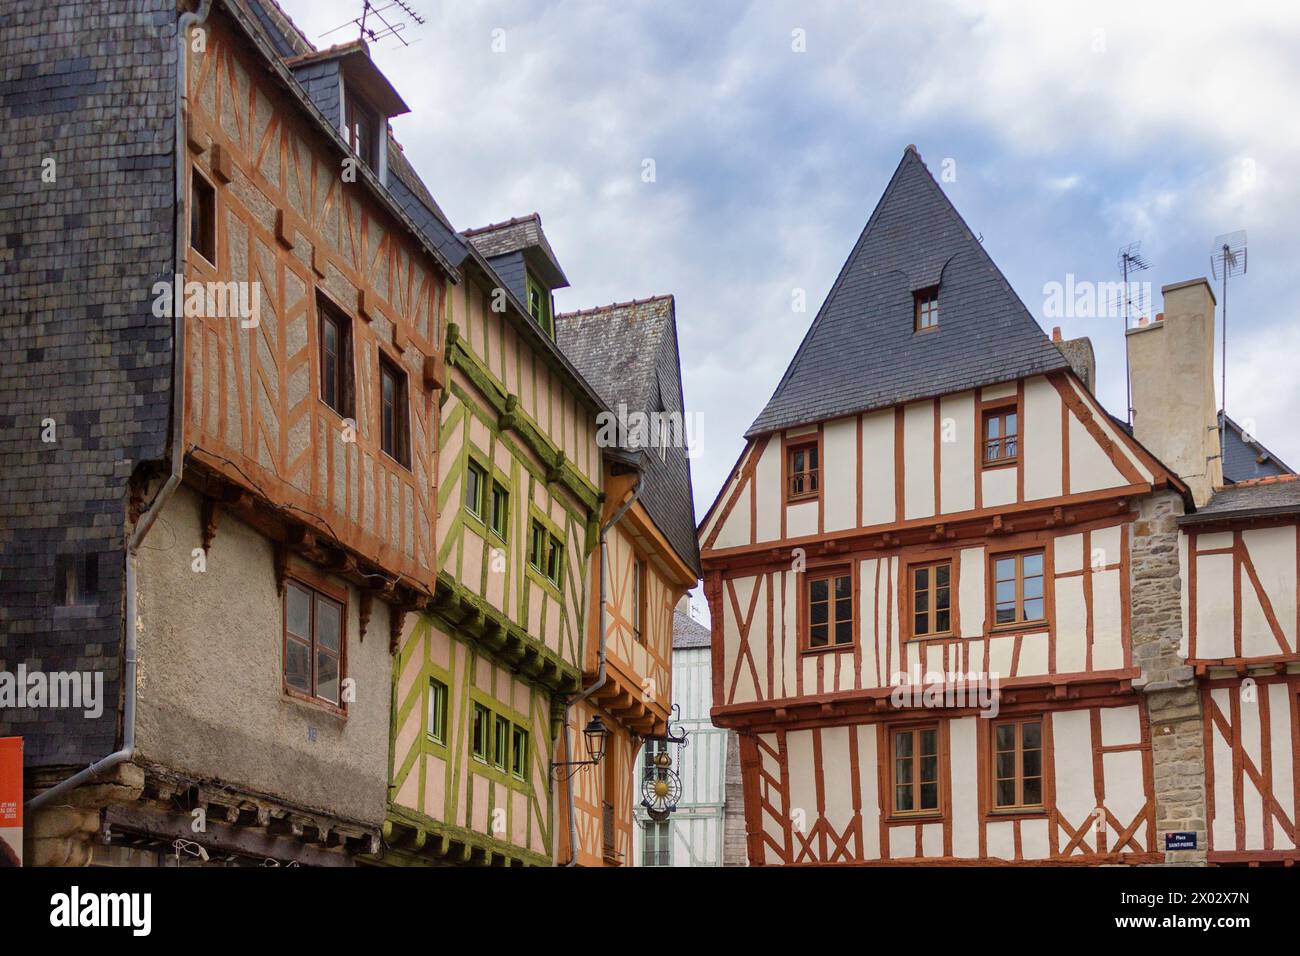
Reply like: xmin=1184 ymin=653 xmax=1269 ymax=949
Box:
xmin=138 ymin=486 xmax=391 ymax=825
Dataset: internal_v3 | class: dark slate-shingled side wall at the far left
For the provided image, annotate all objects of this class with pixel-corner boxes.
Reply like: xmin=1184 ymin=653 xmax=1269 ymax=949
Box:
xmin=0 ymin=0 xmax=177 ymax=769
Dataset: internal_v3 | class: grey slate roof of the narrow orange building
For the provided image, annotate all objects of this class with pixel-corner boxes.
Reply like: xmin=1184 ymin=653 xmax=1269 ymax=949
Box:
xmin=555 ymin=295 xmax=699 ymax=574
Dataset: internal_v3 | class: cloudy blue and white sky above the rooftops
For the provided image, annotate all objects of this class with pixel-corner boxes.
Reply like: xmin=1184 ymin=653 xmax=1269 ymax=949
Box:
xmin=281 ymin=0 xmax=1300 ymax=546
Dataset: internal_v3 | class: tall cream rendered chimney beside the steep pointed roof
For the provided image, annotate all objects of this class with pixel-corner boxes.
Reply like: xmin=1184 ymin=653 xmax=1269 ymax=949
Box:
xmin=1125 ymin=277 xmax=1223 ymax=507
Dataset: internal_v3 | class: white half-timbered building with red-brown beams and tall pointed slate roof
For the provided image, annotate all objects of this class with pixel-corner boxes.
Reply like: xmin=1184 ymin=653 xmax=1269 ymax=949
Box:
xmin=699 ymin=147 xmax=1196 ymax=864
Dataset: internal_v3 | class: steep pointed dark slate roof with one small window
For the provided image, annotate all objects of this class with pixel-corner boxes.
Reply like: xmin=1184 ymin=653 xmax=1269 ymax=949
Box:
xmin=746 ymin=147 xmax=1069 ymax=438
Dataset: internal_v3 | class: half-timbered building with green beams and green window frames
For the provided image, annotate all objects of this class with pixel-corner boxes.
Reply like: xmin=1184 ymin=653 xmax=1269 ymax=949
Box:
xmin=386 ymin=216 xmax=605 ymax=865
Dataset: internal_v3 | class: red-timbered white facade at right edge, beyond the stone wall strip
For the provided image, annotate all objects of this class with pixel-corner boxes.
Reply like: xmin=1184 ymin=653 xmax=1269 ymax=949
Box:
xmin=1182 ymin=494 xmax=1300 ymax=864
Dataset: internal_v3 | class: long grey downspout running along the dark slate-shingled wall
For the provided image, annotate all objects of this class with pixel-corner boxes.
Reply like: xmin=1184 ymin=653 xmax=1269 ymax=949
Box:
xmin=26 ymin=0 xmax=212 ymax=812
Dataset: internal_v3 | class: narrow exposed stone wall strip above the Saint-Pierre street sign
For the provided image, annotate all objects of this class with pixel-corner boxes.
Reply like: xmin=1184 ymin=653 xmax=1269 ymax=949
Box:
xmin=1128 ymin=492 xmax=1209 ymax=865
